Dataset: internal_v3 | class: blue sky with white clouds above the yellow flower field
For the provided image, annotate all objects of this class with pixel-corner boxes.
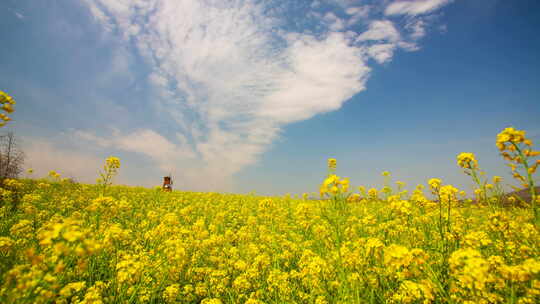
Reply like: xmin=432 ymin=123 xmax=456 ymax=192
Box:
xmin=0 ymin=0 xmax=540 ymax=195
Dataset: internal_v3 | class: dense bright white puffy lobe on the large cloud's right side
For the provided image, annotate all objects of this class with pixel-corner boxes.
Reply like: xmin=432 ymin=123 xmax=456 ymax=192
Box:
xmin=261 ymin=33 xmax=369 ymax=123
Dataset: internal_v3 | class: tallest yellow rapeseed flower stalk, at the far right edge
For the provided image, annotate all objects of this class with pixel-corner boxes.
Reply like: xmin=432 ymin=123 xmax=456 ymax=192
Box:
xmin=496 ymin=127 xmax=540 ymax=222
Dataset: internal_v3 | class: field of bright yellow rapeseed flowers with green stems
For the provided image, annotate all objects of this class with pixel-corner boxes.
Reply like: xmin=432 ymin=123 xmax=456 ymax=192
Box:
xmin=0 ymin=128 xmax=540 ymax=304
